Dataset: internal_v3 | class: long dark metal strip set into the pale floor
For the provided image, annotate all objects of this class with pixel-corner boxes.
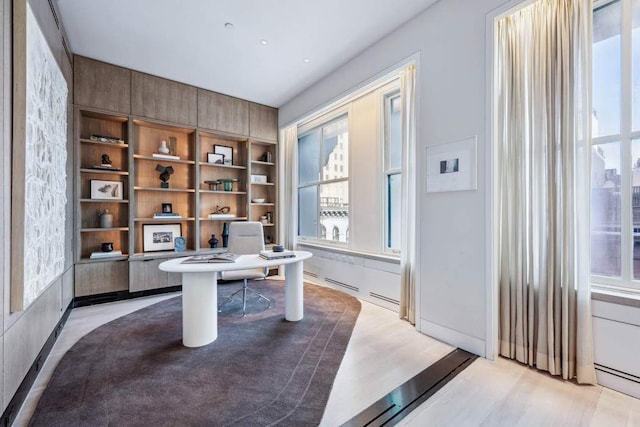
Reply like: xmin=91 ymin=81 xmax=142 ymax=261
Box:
xmin=343 ymin=349 xmax=478 ymax=427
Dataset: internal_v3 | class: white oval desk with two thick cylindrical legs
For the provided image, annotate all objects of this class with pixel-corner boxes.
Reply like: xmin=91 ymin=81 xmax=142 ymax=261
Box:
xmin=159 ymin=251 xmax=312 ymax=347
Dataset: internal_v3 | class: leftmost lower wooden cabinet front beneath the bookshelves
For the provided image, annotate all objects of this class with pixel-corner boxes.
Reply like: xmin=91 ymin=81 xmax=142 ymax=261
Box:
xmin=75 ymin=260 xmax=129 ymax=297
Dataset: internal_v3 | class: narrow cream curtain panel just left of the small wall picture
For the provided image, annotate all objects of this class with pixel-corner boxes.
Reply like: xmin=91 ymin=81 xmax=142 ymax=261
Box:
xmin=399 ymin=65 xmax=417 ymax=325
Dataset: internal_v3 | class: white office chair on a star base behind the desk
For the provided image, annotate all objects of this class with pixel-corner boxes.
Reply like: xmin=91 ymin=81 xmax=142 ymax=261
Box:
xmin=218 ymin=221 xmax=271 ymax=316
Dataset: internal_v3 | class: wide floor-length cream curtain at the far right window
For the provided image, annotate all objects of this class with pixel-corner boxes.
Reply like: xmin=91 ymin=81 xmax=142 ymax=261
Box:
xmin=496 ymin=0 xmax=596 ymax=384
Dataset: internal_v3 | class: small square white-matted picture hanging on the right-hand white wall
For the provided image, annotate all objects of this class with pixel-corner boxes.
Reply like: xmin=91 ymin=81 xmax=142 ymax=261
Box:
xmin=426 ymin=136 xmax=477 ymax=193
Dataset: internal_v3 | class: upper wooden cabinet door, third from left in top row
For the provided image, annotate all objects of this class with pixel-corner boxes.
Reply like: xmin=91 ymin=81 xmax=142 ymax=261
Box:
xmin=198 ymin=89 xmax=249 ymax=136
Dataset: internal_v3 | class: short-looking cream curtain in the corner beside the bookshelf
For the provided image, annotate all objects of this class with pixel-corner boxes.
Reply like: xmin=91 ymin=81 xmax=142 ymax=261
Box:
xmin=280 ymin=126 xmax=298 ymax=249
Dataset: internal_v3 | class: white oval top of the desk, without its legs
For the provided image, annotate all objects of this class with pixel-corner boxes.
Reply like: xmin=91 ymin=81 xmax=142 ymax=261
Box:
xmin=158 ymin=251 xmax=312 ymax=273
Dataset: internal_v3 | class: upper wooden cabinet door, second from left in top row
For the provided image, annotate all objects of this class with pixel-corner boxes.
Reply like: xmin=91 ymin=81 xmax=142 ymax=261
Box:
xmin=131 ymin=71 xmax=198 ymax=126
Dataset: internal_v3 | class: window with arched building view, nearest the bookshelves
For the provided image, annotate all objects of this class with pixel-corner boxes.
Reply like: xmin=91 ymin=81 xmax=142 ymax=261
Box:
xmin=298 ymin=115 xmax=349 ymax=243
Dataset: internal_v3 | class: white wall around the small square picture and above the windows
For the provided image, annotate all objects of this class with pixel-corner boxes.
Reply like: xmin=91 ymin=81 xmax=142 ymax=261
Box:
xmin=279 ymin=0 xmax=505 ymax=355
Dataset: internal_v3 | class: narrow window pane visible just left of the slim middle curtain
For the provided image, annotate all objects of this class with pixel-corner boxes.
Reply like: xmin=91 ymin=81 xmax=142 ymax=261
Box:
xmin=383 ymin=91 xmax=402 ymax=253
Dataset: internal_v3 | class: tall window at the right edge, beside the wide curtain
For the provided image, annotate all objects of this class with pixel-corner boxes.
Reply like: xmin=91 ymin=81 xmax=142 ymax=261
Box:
xmin=591 ymin=0 xmax=640 ymax=289
